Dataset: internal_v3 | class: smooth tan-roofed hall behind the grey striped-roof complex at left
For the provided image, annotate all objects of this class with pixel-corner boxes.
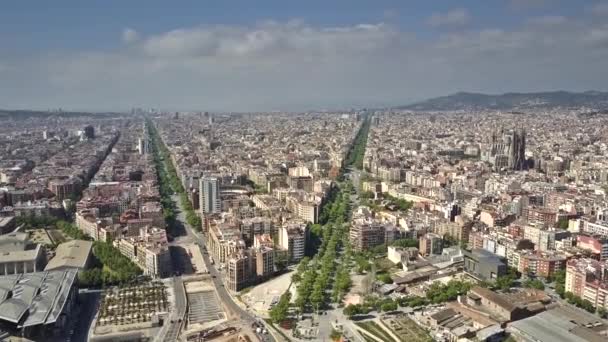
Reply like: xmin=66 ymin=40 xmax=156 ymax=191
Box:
xmin=45 ymin=240 xmax=93 ymax=271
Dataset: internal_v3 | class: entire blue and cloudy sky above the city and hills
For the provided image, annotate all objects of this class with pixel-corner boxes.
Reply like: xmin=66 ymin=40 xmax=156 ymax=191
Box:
xmin=0 ymin=0 xmax=608 ymax=112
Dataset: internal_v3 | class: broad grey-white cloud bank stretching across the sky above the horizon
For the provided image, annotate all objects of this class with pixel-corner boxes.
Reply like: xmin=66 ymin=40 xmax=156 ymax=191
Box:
xmin=0 ymin=17 xmax=608 ymax=111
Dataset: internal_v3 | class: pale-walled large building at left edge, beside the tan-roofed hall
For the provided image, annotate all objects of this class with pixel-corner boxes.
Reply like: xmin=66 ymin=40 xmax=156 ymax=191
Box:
xmin=0 ymin=232 xmax=46 ymax=275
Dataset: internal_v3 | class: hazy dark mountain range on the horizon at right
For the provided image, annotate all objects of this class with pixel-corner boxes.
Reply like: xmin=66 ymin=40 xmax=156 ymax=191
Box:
xmin=396 ymin=91 xmax=608 ymax=111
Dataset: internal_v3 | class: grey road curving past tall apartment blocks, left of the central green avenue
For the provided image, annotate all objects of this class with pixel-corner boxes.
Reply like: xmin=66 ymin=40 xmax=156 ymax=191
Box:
xmin=172 ymin=194 xmax=275 ymax=342
